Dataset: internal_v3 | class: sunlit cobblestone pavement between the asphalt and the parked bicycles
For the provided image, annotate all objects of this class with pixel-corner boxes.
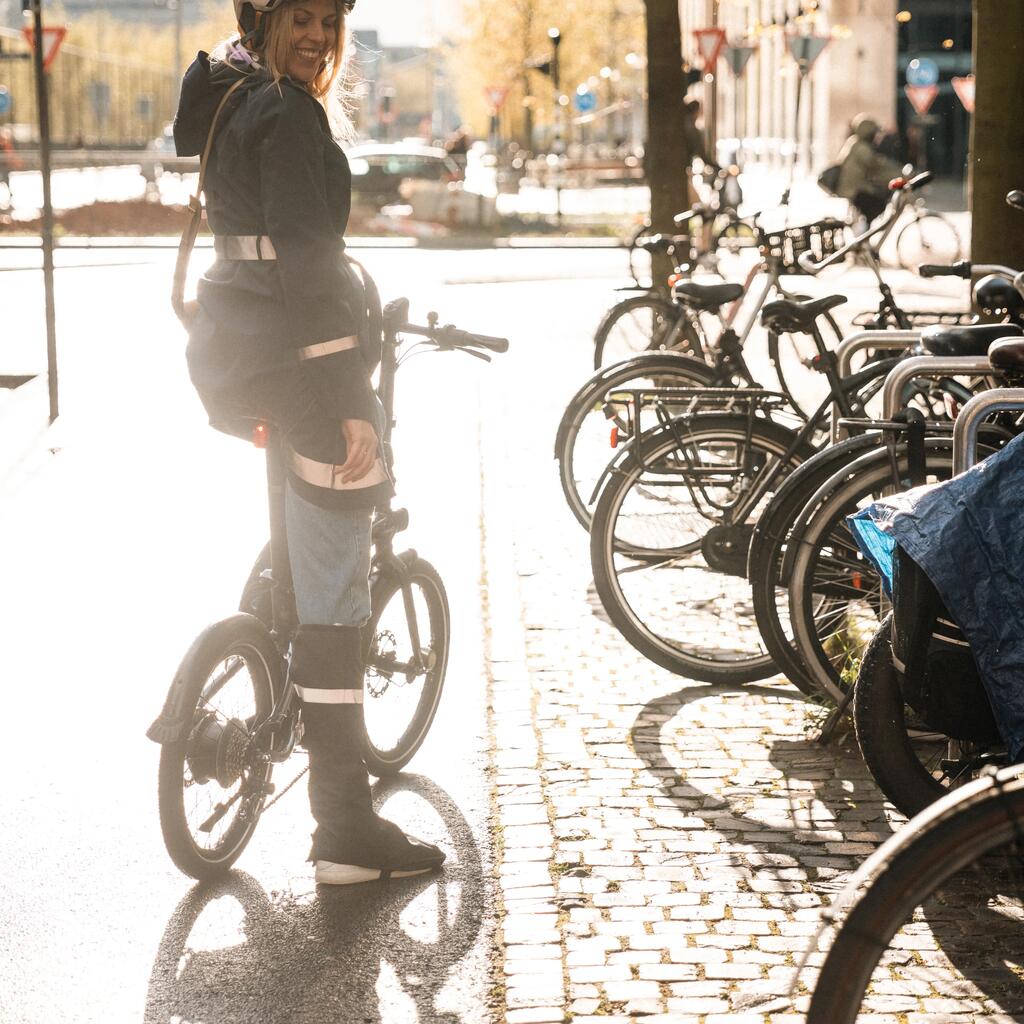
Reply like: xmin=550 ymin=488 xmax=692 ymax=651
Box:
xmin=475 ymin=272 xmax=1018 ymax=1024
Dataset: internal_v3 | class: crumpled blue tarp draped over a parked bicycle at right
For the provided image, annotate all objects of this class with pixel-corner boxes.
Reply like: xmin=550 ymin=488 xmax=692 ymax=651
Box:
xmin=847 ymin=435 xmax=1024 ymax=761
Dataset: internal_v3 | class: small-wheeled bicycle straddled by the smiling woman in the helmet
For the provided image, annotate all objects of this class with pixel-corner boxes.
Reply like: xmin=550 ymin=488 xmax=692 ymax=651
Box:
xmin=146 ymin=299 xmax=508 ymax=879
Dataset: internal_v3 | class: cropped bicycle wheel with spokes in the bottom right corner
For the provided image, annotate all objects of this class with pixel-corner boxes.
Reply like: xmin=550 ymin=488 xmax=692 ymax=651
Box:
xmin=807 ymin=768 xmax=1024 ymax=1024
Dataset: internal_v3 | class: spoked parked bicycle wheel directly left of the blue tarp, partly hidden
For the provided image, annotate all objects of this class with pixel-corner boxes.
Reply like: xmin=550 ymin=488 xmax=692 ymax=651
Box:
xmin=790 ymin=446 xmax=952 ymax=699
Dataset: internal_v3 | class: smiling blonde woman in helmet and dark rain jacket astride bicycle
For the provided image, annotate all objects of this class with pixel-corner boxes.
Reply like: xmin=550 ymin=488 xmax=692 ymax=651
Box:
xmin=174 ymin=0 xmax=444 ymax=885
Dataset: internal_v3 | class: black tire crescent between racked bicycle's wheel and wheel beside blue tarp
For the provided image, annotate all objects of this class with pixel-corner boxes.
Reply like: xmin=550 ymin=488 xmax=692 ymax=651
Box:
xmin=746 ymin=434 xmax=878 ymax=696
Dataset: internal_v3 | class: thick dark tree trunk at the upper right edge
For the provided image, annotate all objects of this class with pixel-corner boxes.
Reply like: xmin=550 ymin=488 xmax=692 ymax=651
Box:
xmin=969 ymin=0 xmax=1024 ymax=270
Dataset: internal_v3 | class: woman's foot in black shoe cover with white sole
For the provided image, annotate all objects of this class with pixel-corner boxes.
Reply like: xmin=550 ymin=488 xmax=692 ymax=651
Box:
xmin=309 ymin=818 xmax=444 ymax=886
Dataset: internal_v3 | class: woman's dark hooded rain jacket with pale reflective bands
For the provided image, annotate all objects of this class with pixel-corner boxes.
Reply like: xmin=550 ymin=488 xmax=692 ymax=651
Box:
xmin=174 ymin=52 xmax=391 ymax=507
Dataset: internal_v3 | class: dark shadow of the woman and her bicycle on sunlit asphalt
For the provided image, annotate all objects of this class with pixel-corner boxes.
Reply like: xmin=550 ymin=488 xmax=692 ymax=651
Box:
xmin=144 ymin=776 xmax=489 ymax=1024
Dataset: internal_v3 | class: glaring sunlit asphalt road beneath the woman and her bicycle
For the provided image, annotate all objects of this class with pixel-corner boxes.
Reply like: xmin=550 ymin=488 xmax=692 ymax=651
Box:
xmin=0 ymin=243 xmax=966 ymax=1024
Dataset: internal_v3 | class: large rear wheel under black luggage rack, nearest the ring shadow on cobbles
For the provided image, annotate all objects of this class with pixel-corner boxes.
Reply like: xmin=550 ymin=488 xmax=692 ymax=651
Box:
xmin=590 ymin=414 xmax=810 ymax=683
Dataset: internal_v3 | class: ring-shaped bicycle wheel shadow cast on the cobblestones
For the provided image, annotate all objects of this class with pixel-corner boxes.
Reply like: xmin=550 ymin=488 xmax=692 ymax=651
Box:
xmin=631 ymin=684 xmax=892 ymax=894
